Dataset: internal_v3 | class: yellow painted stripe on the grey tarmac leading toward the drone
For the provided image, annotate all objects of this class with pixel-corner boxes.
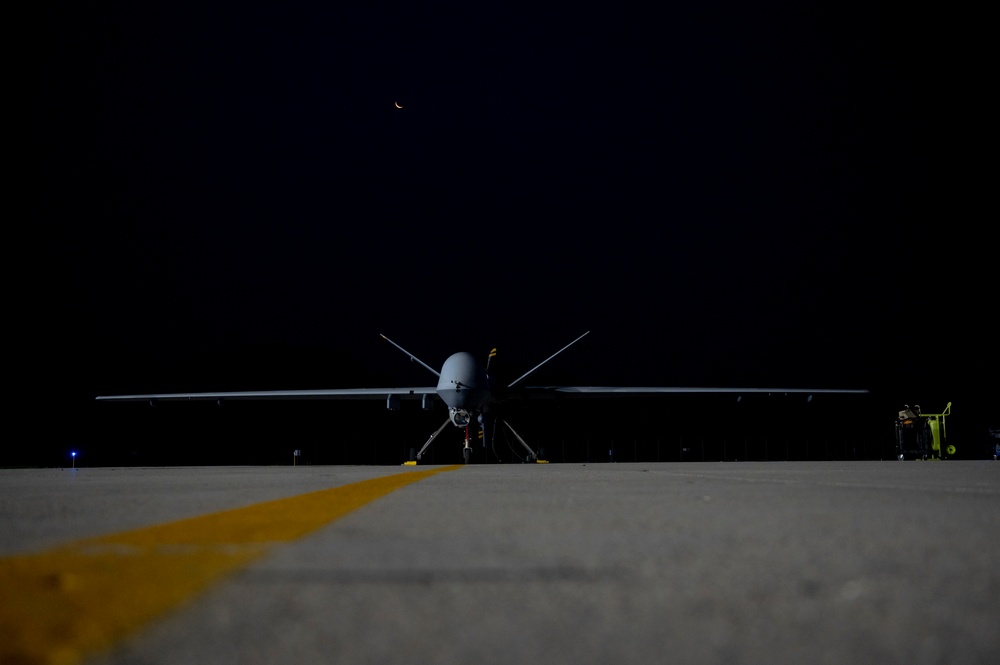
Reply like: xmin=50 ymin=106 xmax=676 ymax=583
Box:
xmin=0 ymin=465 xmax=461 ymax=665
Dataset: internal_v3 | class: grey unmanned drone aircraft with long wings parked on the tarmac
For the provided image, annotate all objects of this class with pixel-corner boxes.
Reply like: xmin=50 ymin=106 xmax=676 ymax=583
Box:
xmin=96 ymin=331 xmax=868 ymax=464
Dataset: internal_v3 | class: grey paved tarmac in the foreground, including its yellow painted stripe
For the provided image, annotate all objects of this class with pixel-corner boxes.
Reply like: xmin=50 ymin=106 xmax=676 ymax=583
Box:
xmin=0 ymin=460 xmax=1000 ymax=665
